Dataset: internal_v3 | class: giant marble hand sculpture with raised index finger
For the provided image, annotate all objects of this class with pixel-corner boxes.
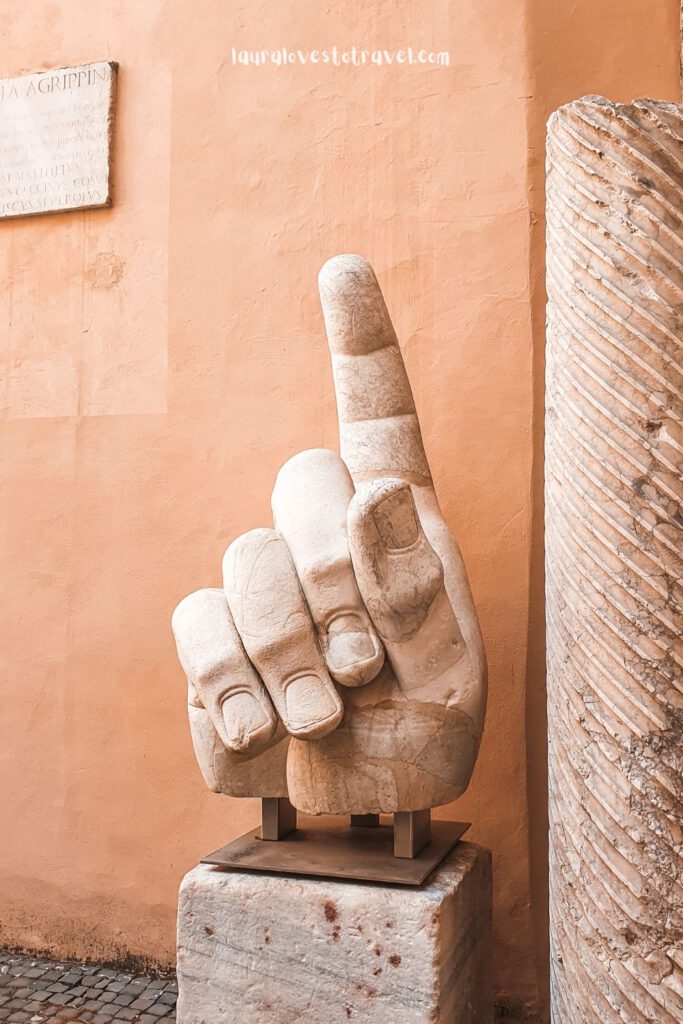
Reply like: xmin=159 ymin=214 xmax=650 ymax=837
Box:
xmin=173 ymin=256 xmax=486 ymax=814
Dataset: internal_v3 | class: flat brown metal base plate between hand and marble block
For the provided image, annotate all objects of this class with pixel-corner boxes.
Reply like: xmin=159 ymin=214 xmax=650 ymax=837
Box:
xmin=202 ymin=814 xmax=470 ymax=886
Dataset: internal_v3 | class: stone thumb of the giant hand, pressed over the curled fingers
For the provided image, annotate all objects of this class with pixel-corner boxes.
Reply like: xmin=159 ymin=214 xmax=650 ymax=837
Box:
xmin=347 ymin=478 xmax=465 ymax=699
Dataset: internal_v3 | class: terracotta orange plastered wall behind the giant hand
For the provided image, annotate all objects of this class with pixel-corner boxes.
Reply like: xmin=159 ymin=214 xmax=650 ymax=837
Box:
xmin=0 ymin=0 xmax=679 ymax=1013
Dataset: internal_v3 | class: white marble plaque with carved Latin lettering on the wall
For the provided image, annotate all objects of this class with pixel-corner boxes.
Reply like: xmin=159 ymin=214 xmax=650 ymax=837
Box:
xmin=0 ymin=61 xmax=118 ymax=218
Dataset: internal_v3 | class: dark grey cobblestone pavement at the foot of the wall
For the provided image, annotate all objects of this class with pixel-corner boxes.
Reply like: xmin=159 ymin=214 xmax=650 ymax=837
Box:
xmin=0 ymin=950 xmax=178 ymax=1024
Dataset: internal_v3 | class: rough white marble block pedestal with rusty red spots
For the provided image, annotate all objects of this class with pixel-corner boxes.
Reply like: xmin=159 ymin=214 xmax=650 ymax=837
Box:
xmin=177 ymin=843 xmax=493 ymax=1024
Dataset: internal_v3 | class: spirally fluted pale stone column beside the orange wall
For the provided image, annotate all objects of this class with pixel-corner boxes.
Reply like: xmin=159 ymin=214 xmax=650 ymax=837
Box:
xmin=546 ymin=97 xmax=683 ymax=1024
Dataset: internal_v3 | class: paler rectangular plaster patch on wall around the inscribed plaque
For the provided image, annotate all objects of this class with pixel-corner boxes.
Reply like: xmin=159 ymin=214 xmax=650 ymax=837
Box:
xmin=0 ymin=61 xmax=171 ymax=419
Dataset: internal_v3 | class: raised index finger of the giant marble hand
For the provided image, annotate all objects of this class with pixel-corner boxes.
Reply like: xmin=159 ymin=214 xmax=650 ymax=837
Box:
xmin=318 ymin=255 xmax=431 ymax=484
